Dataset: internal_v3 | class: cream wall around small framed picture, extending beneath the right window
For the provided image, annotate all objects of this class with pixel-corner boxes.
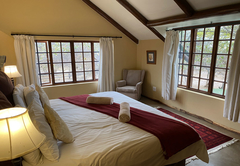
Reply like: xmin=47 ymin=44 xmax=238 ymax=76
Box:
xmin=137 ymin=40 xmax=240 ymax=132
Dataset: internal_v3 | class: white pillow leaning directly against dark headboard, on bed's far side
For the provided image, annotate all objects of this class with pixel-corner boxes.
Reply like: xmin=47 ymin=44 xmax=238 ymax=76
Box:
xmin=13 ymin=84 xmax=27 ymax=108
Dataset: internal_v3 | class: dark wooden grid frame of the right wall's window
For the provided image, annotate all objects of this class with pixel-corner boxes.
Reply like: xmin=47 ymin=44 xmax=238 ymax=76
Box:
xmin=178 ymin=22 xmax=239 ymax=98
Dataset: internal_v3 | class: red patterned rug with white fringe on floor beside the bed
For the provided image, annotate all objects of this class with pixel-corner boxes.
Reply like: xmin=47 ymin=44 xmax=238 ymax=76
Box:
xmin=158 ymin=108 xmax=238 ymax=164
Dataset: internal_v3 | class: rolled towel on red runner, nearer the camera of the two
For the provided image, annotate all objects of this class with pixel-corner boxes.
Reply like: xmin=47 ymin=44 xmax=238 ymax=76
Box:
xmin=118 ymin=102 xmax=131 ymax=122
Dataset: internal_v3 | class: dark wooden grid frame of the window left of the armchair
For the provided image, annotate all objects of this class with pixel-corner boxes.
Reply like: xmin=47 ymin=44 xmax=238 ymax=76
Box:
xmin=34 ymin=40 xmax=100 ymax=86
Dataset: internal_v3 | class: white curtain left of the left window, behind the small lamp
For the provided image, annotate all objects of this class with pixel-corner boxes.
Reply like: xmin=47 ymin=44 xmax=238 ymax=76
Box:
xmin=13 ymin=35 xmax=39 ymax=86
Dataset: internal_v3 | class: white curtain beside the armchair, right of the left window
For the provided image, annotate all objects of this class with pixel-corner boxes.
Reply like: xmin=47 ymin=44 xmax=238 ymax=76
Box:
xmin=97 ymin=38 xmax=114 ymax=92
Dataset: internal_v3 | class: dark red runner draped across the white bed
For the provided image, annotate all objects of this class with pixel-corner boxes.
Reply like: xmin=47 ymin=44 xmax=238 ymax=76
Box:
xmin=60 ymin=95 xmax=201 ymax=159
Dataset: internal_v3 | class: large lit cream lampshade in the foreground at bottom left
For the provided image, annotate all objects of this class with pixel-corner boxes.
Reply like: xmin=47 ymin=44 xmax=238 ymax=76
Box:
xmin=0 ymin=107 xmax=46 ymax=161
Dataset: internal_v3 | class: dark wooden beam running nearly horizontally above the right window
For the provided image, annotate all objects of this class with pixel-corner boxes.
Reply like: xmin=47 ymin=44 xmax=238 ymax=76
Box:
xmin=147 ymin=3 xmax=240 ymax=26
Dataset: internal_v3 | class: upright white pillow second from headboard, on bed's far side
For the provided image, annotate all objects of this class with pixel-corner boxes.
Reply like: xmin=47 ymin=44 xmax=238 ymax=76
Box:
xmin=23 ymin=84 xmax=42 ymax=106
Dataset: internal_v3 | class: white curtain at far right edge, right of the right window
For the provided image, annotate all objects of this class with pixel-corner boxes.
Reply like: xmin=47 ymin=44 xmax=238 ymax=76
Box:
xmin=223 ymin=28 xmax=240 ymax=123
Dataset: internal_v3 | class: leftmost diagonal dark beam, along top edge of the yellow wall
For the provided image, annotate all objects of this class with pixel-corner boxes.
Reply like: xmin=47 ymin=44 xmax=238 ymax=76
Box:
xmin=82 ymin=0 xmax=139 ymax=44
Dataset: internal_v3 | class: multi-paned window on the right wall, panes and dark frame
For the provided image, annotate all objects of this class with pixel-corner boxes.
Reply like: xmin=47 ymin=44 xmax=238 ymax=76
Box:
xmin=178 ymin=25 xmax=239 ymax=97
